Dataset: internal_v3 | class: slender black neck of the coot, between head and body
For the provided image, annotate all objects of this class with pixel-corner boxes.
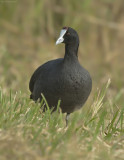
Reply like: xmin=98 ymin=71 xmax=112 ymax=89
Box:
xmin=64 ymin=43 xmax=79 ymax=61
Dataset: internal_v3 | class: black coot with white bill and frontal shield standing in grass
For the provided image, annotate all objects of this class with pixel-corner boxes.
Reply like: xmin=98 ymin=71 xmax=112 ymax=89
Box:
xmin=29 ymin=27 xmax=92 ymax=124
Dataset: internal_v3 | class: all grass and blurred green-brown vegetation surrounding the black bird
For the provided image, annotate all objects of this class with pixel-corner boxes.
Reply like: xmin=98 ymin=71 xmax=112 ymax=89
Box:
xmin=0 ymin=0 xmax=124 ymax=160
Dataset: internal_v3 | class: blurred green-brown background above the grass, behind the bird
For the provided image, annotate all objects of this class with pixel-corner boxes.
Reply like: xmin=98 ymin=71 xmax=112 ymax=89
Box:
xmin=0 ymin=0 xmax=124 ymax=102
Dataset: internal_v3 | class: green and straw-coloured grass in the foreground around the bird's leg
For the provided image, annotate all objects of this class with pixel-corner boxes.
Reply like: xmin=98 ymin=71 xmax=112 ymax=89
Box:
xmin=0 ymin=80 xmax=124 ymax=160
